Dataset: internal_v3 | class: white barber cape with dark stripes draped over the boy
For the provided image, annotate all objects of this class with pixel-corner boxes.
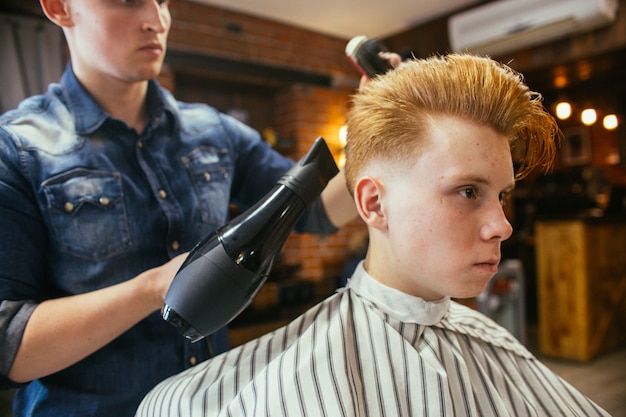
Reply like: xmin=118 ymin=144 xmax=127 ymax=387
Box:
xmin=137 ymin=264 xmax=608 ymax=417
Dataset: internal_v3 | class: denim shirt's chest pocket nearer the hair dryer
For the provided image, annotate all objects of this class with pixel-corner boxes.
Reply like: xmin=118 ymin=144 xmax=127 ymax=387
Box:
xmin=182 ymin=147 xmax=232 ymax=225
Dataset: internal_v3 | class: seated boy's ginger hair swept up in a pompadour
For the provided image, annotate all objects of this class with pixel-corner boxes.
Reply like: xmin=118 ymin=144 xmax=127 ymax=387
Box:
xmin=345 ymin=54 xmax=560 ymax=192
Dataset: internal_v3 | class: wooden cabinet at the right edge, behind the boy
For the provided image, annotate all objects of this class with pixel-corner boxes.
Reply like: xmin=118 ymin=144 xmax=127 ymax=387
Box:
xmin=535 ymin=219 xmax=626 ymax=361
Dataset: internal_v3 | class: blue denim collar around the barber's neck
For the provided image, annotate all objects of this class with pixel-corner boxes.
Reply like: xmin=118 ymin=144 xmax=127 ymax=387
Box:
xmin=61 ymin=63 xmax=176 ymax=135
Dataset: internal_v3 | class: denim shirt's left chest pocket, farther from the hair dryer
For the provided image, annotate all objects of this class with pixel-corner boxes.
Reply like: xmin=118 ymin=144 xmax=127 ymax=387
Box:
xmin=42 ymin=168 xmax=131 ymax=260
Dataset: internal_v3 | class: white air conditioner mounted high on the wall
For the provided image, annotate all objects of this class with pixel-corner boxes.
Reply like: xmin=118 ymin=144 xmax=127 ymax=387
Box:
xmin=448 ymin=0 xmax=618 ymax=55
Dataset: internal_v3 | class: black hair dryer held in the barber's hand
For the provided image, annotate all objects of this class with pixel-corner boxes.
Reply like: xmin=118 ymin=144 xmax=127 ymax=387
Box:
xmin=163 ymin=137 xmax=339 ymax=342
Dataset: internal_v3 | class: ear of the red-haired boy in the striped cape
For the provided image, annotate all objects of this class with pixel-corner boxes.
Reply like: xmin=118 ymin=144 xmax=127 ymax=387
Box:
xmin=354 ymin=177 xmax=387 ymax=229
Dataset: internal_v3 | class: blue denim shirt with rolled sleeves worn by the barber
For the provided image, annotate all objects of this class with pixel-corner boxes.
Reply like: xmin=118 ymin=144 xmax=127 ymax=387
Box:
xmin=0 ymin=65 xmax=334 ymax=417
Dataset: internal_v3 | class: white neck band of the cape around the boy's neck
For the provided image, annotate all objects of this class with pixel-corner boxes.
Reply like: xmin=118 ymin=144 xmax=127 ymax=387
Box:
xmin=346 ymin=261 xmax=450 ymax=326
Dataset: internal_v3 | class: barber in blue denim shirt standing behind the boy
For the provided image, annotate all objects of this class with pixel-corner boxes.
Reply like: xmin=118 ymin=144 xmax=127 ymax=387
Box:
xmin=0 ymin=0 xmax=356 ymax=417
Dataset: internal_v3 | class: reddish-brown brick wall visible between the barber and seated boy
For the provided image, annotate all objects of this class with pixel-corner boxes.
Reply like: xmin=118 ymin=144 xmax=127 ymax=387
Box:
xmin=165 ymin=1 xmax=364 ymax=282
